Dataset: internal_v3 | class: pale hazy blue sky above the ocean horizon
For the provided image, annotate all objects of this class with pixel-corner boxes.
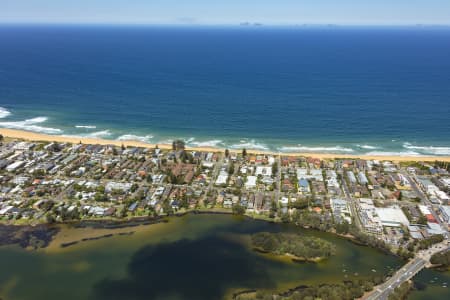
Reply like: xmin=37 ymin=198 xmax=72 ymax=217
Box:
xmin=0 ymin=0 xmax=450 ymax=25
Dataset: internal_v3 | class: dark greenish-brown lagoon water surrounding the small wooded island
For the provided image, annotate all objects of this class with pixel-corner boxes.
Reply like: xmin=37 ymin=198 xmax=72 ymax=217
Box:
xmin=0 ymin=215 xmax=436 ymax=300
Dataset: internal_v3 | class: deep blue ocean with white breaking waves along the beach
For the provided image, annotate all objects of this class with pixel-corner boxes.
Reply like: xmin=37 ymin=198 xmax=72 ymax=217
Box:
xmin=0 ymin=25 xmax=450 ymax=155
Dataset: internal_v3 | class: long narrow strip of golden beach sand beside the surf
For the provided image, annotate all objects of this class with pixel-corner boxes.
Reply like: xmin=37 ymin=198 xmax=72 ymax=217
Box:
xmin=0 ymin=128 xmax=450 ymax=162
